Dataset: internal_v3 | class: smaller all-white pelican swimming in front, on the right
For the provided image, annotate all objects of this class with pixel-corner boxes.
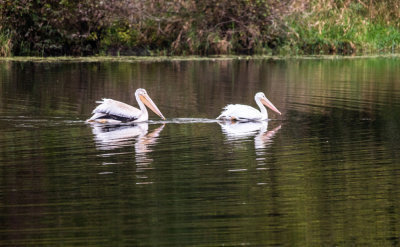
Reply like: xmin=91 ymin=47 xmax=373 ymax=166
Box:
xmin=217 ymin=92 xmax=281 ymax=122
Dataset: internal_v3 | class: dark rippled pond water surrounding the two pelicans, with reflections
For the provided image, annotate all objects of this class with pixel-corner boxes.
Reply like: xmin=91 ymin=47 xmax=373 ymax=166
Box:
xmin=0 ymin=58 xmax=400 ymax=246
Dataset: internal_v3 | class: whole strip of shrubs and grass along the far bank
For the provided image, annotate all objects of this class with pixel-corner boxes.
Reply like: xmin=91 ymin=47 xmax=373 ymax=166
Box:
xmin=0 ymin=0 xmax=400 ymax=56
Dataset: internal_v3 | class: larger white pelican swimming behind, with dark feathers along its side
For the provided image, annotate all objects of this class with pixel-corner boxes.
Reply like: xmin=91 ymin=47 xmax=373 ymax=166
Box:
xmin=87 ymin=88 xmax=165 ymax=124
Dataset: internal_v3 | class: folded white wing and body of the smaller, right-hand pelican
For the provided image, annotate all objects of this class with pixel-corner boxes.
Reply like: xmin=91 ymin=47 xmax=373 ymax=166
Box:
xmin=217 ymin=104 xmax=262 ymax=121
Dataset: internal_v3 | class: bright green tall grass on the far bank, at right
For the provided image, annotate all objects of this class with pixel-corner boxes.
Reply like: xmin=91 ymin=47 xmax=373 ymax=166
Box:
xmin=280 ymin=0 xmax=400 ymax=54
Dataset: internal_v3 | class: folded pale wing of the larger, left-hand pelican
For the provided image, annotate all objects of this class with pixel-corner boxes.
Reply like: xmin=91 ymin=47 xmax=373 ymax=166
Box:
xmin=92 ymin=99 xmax=141 ymax=119
